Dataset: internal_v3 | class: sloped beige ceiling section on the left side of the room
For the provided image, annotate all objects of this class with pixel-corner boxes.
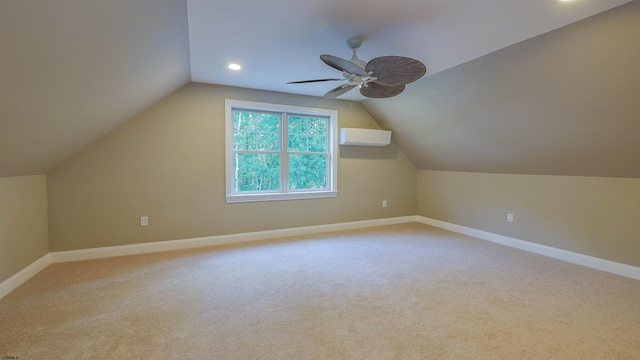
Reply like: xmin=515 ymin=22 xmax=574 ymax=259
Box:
xmin=0 ymin=0 xmax=191 ymax=177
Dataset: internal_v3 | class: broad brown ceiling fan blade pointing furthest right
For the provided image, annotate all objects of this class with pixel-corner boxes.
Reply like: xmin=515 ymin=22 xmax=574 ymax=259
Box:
xmin=366 ymin=56 xmax=427 ymax=86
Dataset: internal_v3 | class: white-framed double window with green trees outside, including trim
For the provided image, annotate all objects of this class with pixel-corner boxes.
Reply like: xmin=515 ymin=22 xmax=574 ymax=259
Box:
xmin=225 ymin=100 xmax=338 ymax=203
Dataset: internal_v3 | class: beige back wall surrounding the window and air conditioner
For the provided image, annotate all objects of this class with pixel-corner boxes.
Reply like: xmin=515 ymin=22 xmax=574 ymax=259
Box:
xmin=48 ymin=83 xmax=417 ymax=251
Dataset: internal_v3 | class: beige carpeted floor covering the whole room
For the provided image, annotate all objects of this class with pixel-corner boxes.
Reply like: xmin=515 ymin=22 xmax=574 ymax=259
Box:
xmin=0 ymin=223 xmax=640 ymax=359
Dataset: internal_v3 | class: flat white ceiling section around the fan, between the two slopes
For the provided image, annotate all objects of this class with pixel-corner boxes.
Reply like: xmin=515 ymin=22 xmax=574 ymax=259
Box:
xmin=188 ymin=0 xmax=629 ymax=100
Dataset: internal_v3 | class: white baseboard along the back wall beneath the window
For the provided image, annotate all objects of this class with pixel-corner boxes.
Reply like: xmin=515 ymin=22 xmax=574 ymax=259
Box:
xmin=50 ymin=216 xmax=416 ymax=263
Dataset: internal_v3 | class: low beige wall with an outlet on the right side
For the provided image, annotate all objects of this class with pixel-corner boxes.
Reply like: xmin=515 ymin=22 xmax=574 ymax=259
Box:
xmin=417 ymin=170 xmax=640 ymax=266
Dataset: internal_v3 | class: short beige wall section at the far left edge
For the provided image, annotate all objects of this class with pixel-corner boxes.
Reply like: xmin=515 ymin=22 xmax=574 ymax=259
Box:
xmin=0 ymin=175 xmax=49 ymax=282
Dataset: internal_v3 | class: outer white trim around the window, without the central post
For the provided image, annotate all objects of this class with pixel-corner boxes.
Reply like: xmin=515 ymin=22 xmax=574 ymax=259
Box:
xmin=224 ymin=99 xmax=338 ymax=203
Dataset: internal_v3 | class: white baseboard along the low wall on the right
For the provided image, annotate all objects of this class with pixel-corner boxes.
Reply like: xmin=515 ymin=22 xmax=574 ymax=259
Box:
xmin=416 ymin=215 xmax=640 ymax=280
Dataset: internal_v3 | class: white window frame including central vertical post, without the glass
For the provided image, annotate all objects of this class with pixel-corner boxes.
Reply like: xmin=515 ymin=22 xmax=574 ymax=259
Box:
xmin=225 ymin=99 xmax=338 ymax=203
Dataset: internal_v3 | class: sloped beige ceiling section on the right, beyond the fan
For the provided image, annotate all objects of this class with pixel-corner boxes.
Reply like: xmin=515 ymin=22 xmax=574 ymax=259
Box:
xmin=363 ymin=1 xmax=640 ymax=178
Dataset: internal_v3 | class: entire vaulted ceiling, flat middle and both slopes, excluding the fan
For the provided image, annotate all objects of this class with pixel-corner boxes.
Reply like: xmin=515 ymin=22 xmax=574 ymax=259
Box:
xmin=0 ymin=0 xmax=640 ymax=177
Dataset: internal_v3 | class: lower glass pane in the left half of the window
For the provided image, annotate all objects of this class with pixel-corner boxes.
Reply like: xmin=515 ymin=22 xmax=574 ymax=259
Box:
xmin=233 ymin=153 xmax=280 ymax=192
